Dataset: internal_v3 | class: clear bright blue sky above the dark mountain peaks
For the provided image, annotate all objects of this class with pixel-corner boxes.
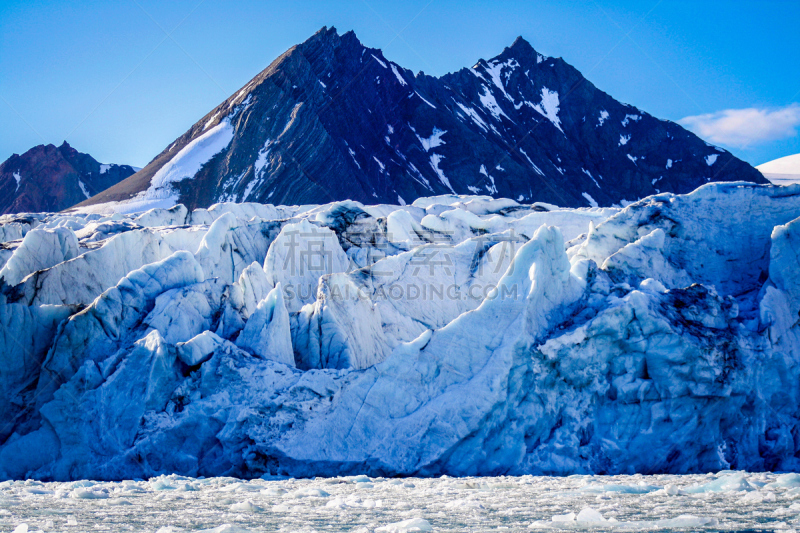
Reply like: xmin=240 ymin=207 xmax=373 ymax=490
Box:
xmin=0 ymin=0 xmax=800 ymax=166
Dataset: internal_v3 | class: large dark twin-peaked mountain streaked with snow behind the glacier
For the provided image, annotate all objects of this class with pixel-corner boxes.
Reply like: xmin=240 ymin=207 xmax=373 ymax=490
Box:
xmin=82 ymin=28 xmax=766 ymax=211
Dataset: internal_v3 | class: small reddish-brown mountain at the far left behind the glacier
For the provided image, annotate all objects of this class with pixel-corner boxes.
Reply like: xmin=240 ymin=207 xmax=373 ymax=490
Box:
xmin=0 ymin=141 xmax=136 ymax=214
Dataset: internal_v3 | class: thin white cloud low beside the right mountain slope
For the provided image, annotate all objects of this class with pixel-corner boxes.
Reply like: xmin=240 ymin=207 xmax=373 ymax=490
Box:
xmin=678 ymin=104 xmax=800 ymax=147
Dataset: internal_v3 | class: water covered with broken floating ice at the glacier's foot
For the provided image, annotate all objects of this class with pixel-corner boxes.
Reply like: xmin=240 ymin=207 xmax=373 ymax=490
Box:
xmin=0 ymin=472 xmax=800 ymax=533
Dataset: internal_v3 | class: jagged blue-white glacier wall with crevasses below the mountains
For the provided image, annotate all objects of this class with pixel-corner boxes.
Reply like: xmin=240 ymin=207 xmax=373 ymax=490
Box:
xmin=0 ymin=182 xmax=800 ymax=481
